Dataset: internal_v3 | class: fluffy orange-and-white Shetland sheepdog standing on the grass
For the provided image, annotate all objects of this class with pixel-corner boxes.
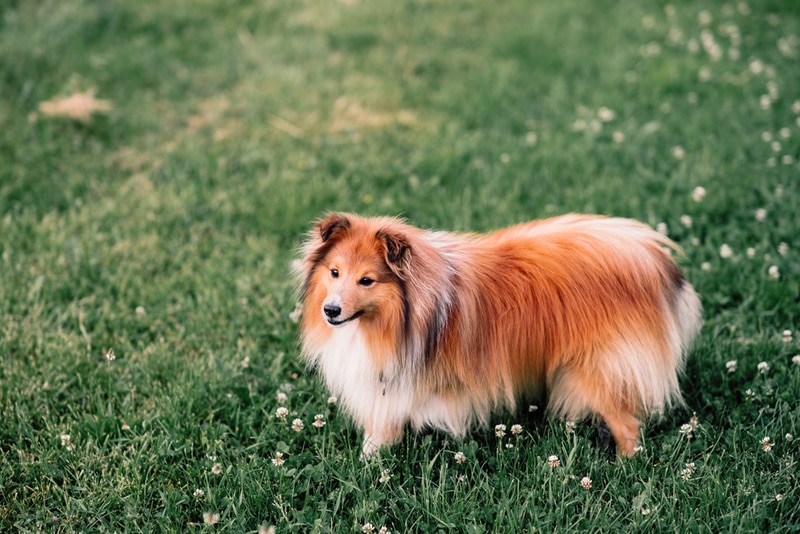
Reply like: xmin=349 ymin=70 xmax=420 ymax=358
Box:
xmin=300 ymin=213 xmax=701 ymax=457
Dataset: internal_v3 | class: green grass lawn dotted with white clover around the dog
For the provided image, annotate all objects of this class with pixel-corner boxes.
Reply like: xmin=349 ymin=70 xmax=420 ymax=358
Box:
xmin=0 ymin=0 xmax=800 ymax=532
